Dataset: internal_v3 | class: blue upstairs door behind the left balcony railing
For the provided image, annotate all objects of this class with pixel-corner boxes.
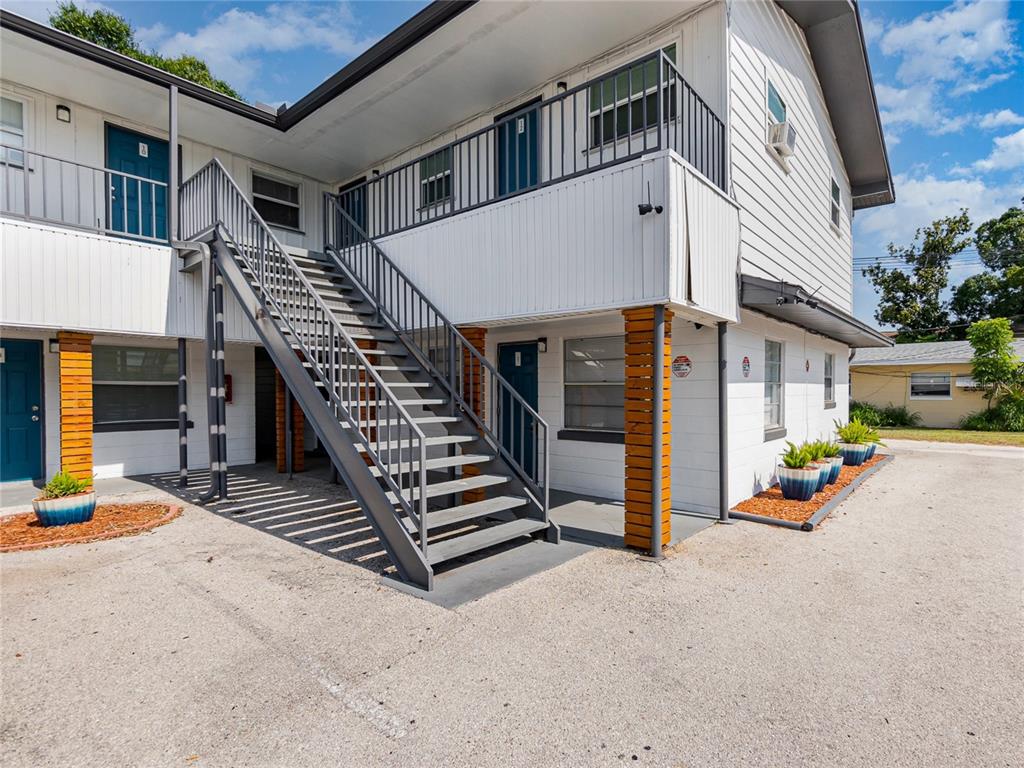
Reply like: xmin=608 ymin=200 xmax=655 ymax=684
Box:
xmin=106 ymin=125 xmax=170 ymax=240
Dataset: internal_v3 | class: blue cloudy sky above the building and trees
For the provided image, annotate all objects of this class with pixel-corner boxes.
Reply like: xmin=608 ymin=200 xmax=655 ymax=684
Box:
xmin=4 ymin=0 xmax=1024 ymax=321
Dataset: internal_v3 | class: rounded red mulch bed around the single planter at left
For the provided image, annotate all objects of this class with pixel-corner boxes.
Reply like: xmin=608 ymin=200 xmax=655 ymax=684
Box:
xmin=0 ymin=503 xmax=181 ymax=552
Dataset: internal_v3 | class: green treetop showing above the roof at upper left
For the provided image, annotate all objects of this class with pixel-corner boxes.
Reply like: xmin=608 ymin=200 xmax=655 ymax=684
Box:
xmin=50 ymin=0 xmax=242 ymax=99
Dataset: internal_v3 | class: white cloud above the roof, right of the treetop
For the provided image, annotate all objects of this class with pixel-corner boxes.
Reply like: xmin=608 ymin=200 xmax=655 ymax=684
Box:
xmin=138 ymin=3 xmax=375 ymax=96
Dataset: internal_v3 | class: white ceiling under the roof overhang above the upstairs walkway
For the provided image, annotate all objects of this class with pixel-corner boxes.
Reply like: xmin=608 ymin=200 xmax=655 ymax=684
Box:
xmin=0 ymin=1 xmax=700 ymax=181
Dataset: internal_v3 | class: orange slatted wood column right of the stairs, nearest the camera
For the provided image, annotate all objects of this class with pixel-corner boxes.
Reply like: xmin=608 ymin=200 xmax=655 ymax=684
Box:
xmin=623 ymin=307 xmax=672 ymax=552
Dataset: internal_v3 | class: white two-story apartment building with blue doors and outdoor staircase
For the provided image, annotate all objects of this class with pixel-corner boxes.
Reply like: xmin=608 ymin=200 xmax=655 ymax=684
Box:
xmin=0 ymin=0 xmax=894 ymax=584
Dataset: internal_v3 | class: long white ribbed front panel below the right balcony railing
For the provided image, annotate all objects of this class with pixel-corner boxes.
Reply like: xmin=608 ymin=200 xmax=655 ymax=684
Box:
xmin=372 ymin=153 xmax=669 ymax=323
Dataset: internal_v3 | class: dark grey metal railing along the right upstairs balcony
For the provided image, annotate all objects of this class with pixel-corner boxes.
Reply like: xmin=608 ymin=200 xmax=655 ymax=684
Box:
xmin=325 ymin=51 xmax=726 ymax=245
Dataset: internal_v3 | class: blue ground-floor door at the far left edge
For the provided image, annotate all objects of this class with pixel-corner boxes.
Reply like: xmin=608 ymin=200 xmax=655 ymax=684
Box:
xmin=0 ymin=339 xmax=43 ymax=482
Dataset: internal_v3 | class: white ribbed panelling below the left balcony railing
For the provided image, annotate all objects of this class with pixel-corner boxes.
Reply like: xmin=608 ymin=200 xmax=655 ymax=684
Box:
xmin=0 ymin=219 xmax=257 ymax=341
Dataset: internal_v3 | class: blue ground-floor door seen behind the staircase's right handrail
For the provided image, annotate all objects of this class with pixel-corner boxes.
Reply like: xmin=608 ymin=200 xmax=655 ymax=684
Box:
xmin=498 ymin=342 xmax=540 ymax=473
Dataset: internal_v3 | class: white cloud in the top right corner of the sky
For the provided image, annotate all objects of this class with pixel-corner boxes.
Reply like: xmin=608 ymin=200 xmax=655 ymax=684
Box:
xmin=879 ymin=0 xmax=1018 ymax=93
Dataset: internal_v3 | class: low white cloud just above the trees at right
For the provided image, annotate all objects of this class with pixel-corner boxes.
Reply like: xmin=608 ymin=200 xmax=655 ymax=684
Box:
xmin=855 ymin=174 xmax=1020 ymax=246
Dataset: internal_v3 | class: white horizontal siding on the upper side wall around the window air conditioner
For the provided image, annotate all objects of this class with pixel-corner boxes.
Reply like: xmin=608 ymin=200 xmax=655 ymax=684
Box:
xmin=730 ymin=0 xmax=853 ymax=310
